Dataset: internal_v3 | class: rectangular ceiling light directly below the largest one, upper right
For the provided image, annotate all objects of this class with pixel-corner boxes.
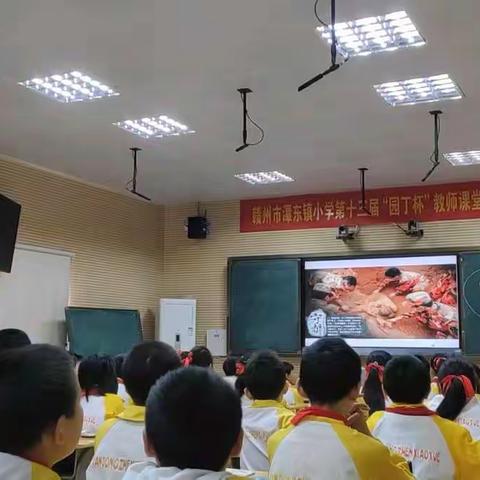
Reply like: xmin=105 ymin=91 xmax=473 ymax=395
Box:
xmin=374 ymin=74 xmax=463 ymax=107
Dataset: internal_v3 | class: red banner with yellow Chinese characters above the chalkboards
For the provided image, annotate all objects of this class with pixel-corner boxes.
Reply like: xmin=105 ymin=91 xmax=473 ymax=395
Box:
xmin=240 ymin=182 xmax=480 ymax=232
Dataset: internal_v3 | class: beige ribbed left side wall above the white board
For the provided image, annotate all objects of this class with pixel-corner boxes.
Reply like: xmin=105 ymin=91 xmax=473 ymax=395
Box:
xmin=0 ymin=160 xmax=163 ymax=338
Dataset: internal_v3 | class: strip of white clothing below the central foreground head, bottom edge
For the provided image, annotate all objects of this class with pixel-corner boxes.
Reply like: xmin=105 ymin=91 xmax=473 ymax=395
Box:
xmin=123 ymin=462 xmax=234 ymax=480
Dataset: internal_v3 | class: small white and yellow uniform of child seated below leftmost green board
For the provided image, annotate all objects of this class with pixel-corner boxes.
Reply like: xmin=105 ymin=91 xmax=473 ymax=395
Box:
xmin=80 ymin=393 xmax=125 ymax=437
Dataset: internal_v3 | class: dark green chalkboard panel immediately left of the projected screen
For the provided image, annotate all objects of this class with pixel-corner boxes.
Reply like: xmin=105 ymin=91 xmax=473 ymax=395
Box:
xmin=228 ymin=258 xmax=301 ymax=354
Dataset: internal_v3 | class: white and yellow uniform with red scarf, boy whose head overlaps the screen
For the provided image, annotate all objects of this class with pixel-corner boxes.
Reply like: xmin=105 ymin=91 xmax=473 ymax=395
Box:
xmin=268 ymin=407 xmax=414 ymax=480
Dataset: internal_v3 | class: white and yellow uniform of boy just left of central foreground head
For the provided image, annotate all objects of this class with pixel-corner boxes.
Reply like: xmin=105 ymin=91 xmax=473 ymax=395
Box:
xmin=87 ymin=405 xmax=149 ymax=480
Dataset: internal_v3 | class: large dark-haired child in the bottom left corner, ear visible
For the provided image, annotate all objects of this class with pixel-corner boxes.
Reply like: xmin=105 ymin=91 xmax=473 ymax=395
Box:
xmin=0 ymin=345 xmax=82 ymax=480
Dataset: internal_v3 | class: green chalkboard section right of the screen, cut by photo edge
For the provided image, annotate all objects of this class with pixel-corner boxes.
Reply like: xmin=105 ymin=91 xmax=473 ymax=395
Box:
xmin=458 ymin=252 xmax=480 ymax=355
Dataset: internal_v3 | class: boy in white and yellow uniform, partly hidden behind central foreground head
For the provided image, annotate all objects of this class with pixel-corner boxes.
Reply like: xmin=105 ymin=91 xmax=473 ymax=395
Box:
xmin=87 ymin=342 xmax=181 ymax=480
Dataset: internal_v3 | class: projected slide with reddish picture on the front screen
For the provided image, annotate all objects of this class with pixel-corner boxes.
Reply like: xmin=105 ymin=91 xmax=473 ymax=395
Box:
xmin=305 ymin=255 xmax=460 ymax=348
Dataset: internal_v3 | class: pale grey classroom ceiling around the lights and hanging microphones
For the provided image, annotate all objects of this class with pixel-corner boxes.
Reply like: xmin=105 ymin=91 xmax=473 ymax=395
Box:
xmin=0 ymin=0 xmax=480 ymax=204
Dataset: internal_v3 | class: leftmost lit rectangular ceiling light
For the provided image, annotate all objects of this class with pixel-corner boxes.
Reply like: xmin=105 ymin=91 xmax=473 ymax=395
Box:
xmin=18 ymin=71 xmax=119 ymax=103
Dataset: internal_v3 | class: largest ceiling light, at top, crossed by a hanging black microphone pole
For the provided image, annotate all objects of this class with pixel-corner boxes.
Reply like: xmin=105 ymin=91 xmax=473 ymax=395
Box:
xmin=317 ymin=11 xmax=425 ymax=57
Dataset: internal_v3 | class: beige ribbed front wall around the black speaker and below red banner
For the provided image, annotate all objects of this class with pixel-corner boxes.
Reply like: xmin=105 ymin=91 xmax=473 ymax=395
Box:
xmin=162 ymin=201 xmax=480 ymax=343
